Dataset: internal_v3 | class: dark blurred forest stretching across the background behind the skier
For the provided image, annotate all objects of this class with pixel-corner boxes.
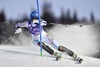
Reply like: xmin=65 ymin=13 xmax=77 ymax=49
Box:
xmin=0 ymin=2 xmax=100 ymax=43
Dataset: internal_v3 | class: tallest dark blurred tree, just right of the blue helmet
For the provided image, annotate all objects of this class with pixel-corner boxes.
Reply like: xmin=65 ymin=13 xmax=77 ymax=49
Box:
xmin=42 ymin=1 xmax=56 ymax=28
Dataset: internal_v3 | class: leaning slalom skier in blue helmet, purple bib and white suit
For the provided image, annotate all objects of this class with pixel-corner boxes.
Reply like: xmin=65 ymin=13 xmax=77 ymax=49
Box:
xmin=15 ymin=11 xmax=83 ymax=63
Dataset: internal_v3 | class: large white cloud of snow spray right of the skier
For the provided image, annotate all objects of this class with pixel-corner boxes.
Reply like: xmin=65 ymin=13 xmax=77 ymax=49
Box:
xmin=49 ymin=24 xmax=98 ymax=55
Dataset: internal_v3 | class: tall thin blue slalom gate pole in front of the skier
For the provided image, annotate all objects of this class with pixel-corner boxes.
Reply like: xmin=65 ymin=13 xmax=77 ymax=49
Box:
xmin=36 ymin=0 xmax=42 ymax=57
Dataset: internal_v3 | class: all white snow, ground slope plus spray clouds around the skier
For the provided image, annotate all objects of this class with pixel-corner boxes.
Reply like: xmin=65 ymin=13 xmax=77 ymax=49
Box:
xmin=0 ymin=24 xmax=100 ymax=67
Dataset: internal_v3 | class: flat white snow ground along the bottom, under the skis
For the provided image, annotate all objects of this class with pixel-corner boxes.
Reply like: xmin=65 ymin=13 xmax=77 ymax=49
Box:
xmin=0 ymin=46 xmax=100 ymax=67
